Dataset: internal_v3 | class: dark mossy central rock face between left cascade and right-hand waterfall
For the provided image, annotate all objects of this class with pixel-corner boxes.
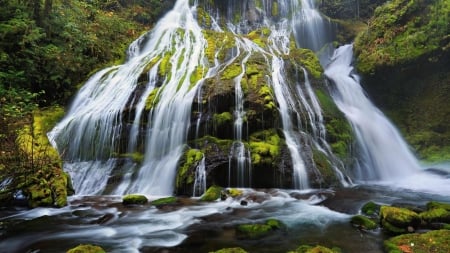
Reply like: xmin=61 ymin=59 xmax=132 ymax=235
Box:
xmin=123 ymin=1 xmax=353 ymax=195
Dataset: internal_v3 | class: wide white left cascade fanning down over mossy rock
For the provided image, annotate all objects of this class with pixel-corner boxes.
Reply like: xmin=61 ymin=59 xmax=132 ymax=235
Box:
xmin=49 ymin=0 xmax=205 ymax=195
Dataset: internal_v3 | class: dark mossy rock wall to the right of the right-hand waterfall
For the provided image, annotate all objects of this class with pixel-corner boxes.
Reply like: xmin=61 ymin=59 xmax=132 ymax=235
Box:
xmin=354 ymin=0 xmax=450 ymax=161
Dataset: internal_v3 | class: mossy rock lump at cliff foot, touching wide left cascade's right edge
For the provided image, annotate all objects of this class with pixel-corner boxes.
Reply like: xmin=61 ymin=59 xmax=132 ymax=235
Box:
xmin=176 ymin=149 xmax=203 ymax=187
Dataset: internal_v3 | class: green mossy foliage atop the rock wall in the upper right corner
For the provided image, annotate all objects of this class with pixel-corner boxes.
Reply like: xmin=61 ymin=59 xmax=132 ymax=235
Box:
xmin=355 ymin=0 xmax=450 ymax=74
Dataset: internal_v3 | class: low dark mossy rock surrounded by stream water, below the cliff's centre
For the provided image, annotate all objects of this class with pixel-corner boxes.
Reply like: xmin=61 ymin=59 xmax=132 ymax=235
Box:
xmin=236 ymin=219 xmax=285 ymax=239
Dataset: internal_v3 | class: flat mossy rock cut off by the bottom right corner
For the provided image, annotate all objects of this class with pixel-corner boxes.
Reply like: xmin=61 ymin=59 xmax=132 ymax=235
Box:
xmin=384 ymin=230 xmax=450 ymax=253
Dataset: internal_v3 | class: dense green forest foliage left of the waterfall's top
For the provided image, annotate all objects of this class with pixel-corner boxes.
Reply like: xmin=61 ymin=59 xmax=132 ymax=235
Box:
xmin=0 ymin=0 xmax=171 ymax=105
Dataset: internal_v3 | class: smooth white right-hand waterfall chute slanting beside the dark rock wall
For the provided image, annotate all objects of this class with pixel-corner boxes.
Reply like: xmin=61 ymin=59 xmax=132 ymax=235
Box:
xmin=325 ymin=45 xmax=420 ymax=181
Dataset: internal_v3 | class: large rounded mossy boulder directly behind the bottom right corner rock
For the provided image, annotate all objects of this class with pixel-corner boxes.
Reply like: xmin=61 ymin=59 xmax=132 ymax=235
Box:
xmin=380 ymin=206 xmax=421 ymax=234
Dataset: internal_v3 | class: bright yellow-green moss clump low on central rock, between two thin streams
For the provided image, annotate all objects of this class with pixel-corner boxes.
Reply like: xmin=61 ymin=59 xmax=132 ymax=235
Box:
xmin=249 ymin=129 xmax=283 ymax=165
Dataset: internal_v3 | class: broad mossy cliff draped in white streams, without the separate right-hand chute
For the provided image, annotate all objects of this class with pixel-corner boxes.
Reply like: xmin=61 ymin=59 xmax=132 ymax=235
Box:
xmin=49 ymin=0 xmax=418 ymax=195
